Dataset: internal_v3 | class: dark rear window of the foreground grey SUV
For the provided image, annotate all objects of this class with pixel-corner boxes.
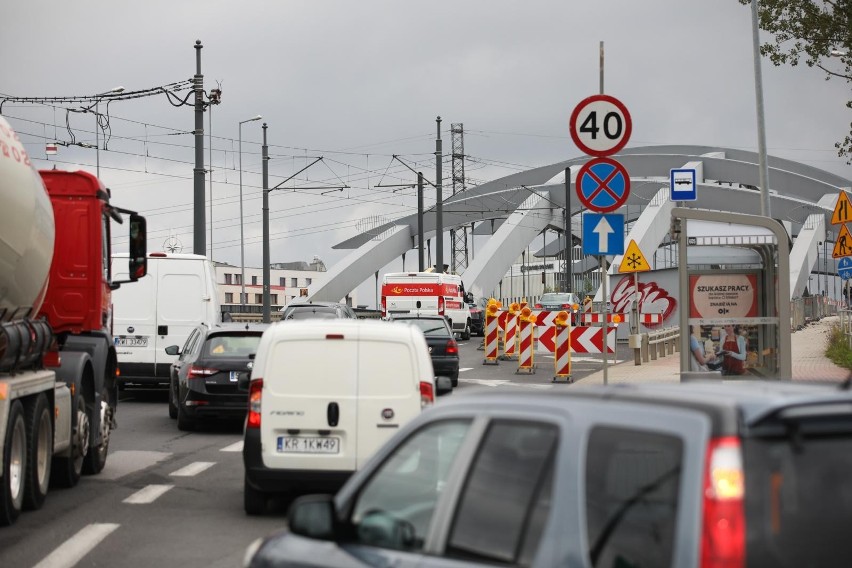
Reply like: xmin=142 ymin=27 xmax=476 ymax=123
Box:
xmin=743 ymin=419 xmax=852 ymax=567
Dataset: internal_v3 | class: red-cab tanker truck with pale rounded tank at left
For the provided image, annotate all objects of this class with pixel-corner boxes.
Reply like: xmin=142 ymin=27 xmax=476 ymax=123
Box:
xmin=0 ymin=116 xmax=147 ymax=525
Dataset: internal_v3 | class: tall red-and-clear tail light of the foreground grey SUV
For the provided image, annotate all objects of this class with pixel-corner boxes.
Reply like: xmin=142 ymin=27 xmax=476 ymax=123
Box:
xmin=701 ymin=436 xmax=746 ymax=568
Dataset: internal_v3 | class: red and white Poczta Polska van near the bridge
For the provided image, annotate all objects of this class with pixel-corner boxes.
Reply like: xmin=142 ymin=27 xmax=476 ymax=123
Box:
xmin=382 ymin=272 xmax=473 ymax=340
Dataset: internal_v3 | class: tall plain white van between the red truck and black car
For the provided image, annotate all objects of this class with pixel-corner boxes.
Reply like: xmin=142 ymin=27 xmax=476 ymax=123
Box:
xmin=112 ymin=252 xmax=222 ymax=388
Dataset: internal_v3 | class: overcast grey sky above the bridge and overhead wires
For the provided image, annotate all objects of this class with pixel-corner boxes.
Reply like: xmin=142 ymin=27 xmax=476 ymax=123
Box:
xmin=0 ymin=0 xmax=852 ymax=306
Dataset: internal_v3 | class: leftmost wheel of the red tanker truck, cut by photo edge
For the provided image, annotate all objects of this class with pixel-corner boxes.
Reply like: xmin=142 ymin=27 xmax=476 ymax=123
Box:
xmin=0 ymin=400 xmax=27 ymax=526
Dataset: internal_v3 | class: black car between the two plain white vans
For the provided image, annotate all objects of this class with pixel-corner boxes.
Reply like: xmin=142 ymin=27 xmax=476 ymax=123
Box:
xmin=166 ymin=323 xmax=269 ymax=430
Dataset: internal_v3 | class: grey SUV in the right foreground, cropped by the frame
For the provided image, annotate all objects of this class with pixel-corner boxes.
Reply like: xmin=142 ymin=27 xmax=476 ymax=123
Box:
xmin=247 ymin=381 xmax=852 ymax=568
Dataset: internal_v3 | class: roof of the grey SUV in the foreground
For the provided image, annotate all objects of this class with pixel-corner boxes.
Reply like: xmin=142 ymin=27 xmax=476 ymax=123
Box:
xmin=430 ymin=380 xmax=852 ymax=435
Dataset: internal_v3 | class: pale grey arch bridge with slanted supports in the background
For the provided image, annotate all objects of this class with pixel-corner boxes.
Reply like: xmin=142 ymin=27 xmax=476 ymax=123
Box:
xmin=309 ymin=146 xmax=852 ymax=301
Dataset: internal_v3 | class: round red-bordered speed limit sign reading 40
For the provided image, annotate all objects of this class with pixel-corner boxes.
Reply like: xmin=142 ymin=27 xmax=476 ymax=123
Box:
xmin=570 ymin=95 xmax=633 ymax=158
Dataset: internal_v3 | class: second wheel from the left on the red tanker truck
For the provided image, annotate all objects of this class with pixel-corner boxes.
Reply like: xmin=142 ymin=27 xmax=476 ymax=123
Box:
xmin=24 ymin=394 xmax=53 ymax=510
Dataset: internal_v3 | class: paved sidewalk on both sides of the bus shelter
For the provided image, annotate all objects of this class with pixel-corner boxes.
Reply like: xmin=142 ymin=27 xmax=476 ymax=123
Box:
xmin=576 ymin=316 xmax=850 ymax=385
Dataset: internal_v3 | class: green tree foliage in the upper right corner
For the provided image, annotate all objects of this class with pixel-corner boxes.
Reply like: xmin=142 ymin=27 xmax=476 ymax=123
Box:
xmin=739 ymin=0 xmax=852 ymax=164
